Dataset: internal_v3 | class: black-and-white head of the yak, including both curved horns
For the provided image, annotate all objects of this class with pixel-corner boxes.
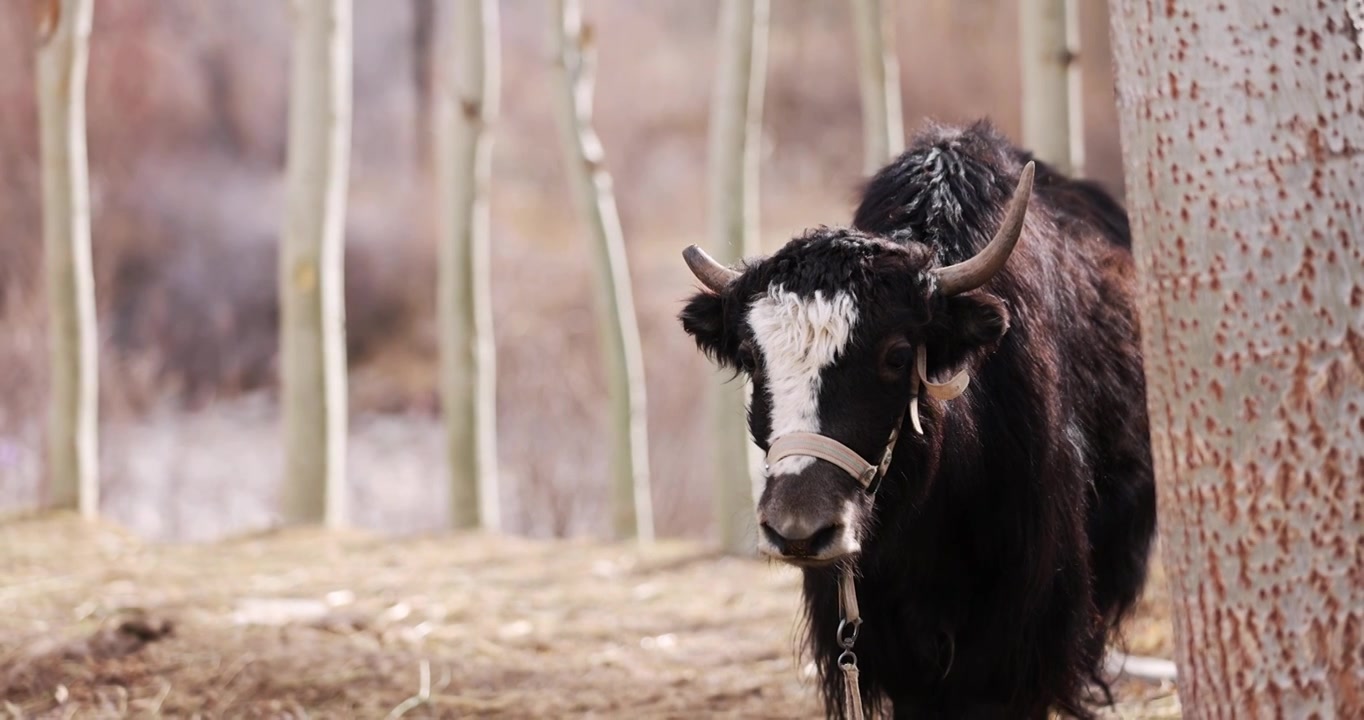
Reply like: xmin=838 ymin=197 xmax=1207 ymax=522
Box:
xmin=681 ymin=164 xmax=1033 ymax=567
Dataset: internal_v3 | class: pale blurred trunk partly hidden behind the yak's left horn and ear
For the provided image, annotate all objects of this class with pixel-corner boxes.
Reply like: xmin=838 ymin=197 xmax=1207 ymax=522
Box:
xmin=708 ymin=0 xmax=769 ymax=554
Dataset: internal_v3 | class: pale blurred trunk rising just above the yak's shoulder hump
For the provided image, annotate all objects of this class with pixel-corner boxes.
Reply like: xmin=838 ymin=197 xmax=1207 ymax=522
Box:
xmin=853 ymin=0 xmax=904 ymax=175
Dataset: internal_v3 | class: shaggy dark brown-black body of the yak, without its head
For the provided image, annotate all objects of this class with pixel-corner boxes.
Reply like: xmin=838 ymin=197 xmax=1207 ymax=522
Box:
xmin=805 ymin=125 xmax=1155 ymax=717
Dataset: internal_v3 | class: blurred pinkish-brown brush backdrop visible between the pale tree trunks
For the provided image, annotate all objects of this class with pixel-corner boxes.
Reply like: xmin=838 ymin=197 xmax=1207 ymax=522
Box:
xmin=0 ymin=0 xmax=1123 ymax=540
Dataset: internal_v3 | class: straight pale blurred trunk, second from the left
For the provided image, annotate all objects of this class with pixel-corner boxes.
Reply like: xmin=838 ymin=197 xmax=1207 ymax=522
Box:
xmin=280 ymin=0 xmax=352 ymax=526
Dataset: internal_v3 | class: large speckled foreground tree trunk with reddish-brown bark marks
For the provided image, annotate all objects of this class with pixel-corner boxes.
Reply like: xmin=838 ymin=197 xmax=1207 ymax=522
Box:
xmin=1110 ymin=0 xmax=1364 ymax=719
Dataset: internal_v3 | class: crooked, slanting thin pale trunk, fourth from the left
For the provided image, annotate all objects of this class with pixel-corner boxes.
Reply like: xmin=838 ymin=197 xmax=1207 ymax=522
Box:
xmin=550 ymin=0 xmax=653 ymax=543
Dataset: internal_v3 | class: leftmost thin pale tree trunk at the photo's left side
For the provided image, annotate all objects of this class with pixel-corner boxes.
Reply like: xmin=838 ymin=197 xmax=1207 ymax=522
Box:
xmin=35 ymin=0 xmax=100 ymax=517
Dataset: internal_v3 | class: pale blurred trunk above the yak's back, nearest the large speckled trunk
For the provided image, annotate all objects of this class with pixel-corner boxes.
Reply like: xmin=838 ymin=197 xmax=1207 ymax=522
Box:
xmin=1019 ymin=0 xmax=1084 ymax=176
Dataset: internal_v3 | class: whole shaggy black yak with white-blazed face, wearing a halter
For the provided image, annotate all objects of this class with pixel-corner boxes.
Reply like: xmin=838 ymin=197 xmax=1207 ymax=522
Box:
xmin=679 ymin=120 xmax=1155 ymax=719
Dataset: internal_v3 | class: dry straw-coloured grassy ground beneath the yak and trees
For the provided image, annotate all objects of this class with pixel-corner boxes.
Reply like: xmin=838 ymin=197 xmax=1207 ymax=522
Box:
xmin=0 ymin=515 xmax=1180 ymax=720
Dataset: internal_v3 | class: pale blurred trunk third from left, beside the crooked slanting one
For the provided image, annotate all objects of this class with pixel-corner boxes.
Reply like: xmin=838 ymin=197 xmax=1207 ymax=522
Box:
xmin=438 ymin=0 xmax=501 ymax=530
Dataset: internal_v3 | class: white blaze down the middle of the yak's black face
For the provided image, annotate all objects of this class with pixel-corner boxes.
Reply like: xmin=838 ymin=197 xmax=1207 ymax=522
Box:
xmin=749 ymin=285 xmax=857 ymax=475
